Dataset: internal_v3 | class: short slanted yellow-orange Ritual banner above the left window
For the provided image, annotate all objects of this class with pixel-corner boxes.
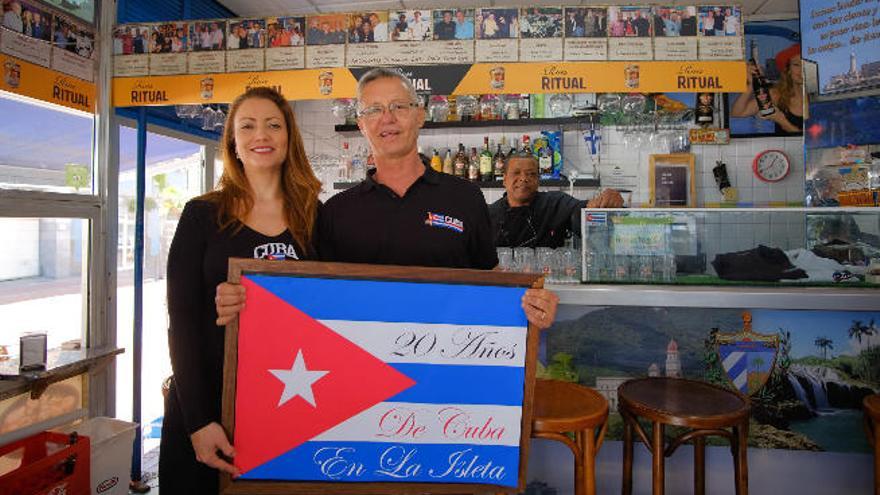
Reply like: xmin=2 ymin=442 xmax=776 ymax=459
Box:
xmin=0 ymin=54 xmax=95 ymax=113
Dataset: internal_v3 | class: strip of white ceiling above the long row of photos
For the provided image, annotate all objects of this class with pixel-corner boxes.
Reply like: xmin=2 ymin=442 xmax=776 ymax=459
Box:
xmin=219 ymin=0 xmax=798 ymax=20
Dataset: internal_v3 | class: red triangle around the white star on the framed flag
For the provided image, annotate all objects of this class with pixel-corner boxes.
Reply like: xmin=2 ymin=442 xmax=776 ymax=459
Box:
xmin=234 ymin=277 xmax=415 ymax=473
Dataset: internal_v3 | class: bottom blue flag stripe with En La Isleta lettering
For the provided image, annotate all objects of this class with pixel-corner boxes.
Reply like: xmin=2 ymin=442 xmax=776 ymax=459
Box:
xmin=240 ymin=442 xmax=519 ymax=491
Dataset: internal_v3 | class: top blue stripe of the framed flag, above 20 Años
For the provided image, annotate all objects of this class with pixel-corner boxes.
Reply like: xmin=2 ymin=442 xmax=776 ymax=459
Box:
xmin=246 ymin=275 xmax=527 ymax=327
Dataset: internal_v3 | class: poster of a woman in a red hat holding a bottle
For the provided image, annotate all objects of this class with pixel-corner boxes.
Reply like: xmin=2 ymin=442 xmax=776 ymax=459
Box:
xmin=726 ymin=19 xmax=803 ymax=138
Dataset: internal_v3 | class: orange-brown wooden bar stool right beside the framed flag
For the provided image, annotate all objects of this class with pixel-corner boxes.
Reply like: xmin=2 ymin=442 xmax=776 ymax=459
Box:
xmin=532 ymin=380 xmax=608 ymax=495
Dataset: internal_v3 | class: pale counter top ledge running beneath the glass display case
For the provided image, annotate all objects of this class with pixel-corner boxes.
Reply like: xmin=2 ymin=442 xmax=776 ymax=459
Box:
xmin=547 ymin=284 xmax=880 ymax=311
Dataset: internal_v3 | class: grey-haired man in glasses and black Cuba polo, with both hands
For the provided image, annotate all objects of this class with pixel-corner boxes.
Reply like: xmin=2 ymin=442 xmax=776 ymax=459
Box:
xmin=216 ymin=68 xmax=559 ymax=328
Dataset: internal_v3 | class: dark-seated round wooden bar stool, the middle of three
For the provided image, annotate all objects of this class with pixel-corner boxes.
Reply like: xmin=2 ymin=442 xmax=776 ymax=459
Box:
xmin=617 ymin=377 xmax=749 ymax=495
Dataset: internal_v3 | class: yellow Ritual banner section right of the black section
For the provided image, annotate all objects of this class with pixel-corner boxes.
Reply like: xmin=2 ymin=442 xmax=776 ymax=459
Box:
xmin=453 ymin=61 xmax=746 ymax=94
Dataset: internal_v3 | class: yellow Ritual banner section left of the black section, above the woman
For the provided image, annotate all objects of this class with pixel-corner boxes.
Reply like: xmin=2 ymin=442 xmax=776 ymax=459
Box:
xmin=113 ymin=68 xmax=357 ymax=107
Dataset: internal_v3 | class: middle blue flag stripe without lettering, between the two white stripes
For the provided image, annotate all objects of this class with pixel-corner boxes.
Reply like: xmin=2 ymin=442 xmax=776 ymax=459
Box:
xmin=388 ymin=363 xmax=525 ymax=406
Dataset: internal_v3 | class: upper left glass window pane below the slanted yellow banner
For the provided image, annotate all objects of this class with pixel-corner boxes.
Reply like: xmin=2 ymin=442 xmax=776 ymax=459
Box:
xmin=0 ymin=92 xmax=95 ymax=194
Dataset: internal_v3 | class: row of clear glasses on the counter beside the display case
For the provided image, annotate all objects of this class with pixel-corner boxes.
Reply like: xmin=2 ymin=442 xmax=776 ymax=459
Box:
xmin=498 ymin=247 xmax=580 ymax=284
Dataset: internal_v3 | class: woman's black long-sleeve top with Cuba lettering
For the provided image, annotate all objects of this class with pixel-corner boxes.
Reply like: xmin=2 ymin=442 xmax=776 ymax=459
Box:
xmin=167 ymin=199 xmax=314 ymax=434
